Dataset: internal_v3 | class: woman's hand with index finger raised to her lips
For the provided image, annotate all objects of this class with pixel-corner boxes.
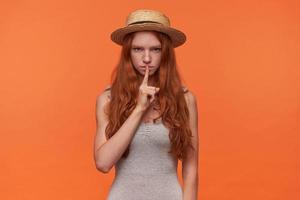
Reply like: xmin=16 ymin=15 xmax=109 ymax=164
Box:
xmin=137 ymin=66 xmax=159 ymax=110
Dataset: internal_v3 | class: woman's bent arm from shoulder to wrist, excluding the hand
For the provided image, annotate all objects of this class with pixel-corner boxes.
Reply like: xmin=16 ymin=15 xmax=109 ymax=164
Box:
xmin=94 ymin=91 xmax=144 ymax=173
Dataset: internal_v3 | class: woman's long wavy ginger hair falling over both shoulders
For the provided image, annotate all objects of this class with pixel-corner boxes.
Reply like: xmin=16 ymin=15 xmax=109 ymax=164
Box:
xmin=105 ymin=31 xmax=195 ymax=160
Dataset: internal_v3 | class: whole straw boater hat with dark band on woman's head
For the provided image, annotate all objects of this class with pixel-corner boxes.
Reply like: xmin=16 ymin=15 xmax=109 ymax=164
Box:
xmin=110 ymin=9 xmax=186 ymax=47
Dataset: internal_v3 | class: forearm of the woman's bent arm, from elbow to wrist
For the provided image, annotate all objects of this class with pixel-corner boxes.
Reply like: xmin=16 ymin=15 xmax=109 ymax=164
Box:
xmin=95 ymin=107 xmax=144 ymax=171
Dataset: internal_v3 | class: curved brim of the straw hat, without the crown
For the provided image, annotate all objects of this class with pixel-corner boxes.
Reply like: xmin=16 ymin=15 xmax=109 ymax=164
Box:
xmin=110 ymin=23 xmax=186 ymax=47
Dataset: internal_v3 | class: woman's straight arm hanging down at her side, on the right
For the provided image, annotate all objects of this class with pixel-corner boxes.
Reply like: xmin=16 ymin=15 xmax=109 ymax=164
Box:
xmin=182 ymin=92 xmax=199 ymax=200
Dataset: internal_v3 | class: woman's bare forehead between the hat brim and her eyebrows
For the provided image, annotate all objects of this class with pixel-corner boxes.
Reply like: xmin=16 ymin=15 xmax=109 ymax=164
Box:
xmin=132 ymin=31 xmax=160 ymax=46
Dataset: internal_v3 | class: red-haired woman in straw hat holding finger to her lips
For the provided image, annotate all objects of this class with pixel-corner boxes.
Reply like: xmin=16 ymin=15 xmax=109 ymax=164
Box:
xmin=94 ymin=10 xmax=198 ymax=200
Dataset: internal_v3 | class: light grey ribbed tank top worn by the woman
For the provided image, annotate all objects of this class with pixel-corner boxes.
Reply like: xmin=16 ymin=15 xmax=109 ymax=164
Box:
xmin=107 ymin=121 xmax=182 ymax=200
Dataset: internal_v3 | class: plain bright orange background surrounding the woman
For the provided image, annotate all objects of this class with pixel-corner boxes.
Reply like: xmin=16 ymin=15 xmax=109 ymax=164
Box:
xmin=0 ymin=0 xmax=300 ymax=200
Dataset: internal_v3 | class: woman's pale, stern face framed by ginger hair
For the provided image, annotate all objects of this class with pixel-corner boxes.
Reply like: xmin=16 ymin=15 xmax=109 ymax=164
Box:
xmin=130 ymin=31 xmax=161 ymax=76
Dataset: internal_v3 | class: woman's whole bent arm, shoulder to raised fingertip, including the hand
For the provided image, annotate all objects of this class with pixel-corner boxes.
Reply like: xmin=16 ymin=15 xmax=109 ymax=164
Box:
xmin=94 ymin=67 xmax=159 ymax=173
